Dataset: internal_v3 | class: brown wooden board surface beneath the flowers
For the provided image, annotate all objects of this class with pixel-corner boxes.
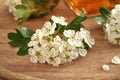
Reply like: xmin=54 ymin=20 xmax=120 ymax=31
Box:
xmin=0 ymin=0 xmax=120 ymax=80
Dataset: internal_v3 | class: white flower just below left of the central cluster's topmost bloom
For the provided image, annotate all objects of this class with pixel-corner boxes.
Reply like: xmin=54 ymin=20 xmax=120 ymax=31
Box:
xmin=42 ymin=22 xmax=56 ymax=36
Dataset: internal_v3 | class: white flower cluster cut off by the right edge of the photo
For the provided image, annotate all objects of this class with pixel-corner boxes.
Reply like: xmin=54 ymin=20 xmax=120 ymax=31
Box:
xmin=105 ymin=5 xmax=120 ymax=45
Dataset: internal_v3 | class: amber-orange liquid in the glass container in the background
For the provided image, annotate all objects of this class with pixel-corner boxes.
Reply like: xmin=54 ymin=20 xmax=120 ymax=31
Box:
xmin=66 ymin=0 xmax=120 ymax=16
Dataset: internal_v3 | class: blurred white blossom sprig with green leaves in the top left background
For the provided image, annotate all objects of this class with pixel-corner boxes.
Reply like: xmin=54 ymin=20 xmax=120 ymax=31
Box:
xmin=5 ymin=0 xmax=59 ymax=23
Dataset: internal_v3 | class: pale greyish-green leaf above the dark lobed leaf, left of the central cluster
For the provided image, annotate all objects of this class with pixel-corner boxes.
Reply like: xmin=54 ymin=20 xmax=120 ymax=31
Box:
xmin=18 ymin=27 xmax=35 ymax=38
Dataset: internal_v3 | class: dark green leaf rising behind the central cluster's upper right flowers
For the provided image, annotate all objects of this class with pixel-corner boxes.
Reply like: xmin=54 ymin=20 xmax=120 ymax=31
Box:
xmin=67 ymin=15 xmax=87 ymax=31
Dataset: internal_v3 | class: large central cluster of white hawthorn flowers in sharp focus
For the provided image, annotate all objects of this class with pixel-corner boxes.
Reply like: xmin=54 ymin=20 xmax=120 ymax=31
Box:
xmin=28 ymin=16 xmax=94 ymax=66
